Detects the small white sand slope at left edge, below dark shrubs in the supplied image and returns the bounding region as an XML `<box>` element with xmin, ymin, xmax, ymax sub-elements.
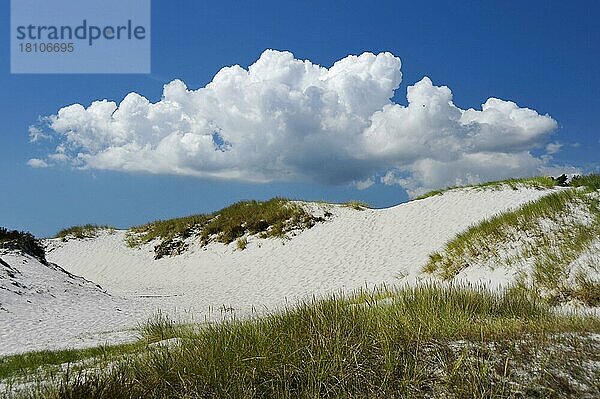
<box><xmin>0</xmin><ymin>252</ymin><xmax>138</xmax><ymax>355</ymax></box>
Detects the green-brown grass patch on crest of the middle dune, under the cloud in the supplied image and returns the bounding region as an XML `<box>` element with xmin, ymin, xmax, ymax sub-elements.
<box><xmin>127</xmin><ymin>198</ymin><xmax>317</xmax><ymax>256</ymax></box>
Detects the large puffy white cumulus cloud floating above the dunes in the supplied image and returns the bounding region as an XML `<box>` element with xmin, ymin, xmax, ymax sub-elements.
<box><xmin>32</xmin><ymin>50</ymin><xmax>557</xmax><ymax>193</ymax></box>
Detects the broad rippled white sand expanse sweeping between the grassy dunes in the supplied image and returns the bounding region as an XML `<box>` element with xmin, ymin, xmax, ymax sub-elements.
<box><xmin>0</xmin><ymin>189</ymin><xmax>548</xmax><ymax>354</ymax></box>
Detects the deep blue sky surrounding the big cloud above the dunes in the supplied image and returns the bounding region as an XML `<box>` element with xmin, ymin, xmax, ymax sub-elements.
<box><xmin>0</xmin><ymin>0</ymin><xmax>600</xmax><ymax>236</ymax></box>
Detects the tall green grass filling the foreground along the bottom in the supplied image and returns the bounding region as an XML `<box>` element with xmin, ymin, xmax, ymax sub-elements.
<box><xmin>4</xmin><ymin>286</ymin><xmax>600</xmax><ymax>398</ymax></box>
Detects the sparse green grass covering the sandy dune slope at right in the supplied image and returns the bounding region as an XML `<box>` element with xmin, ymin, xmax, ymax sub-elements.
<box><xmin>424</xmin><ymin>189</ymin><xmax>600</xmax><ymax>304</ymax></box>
